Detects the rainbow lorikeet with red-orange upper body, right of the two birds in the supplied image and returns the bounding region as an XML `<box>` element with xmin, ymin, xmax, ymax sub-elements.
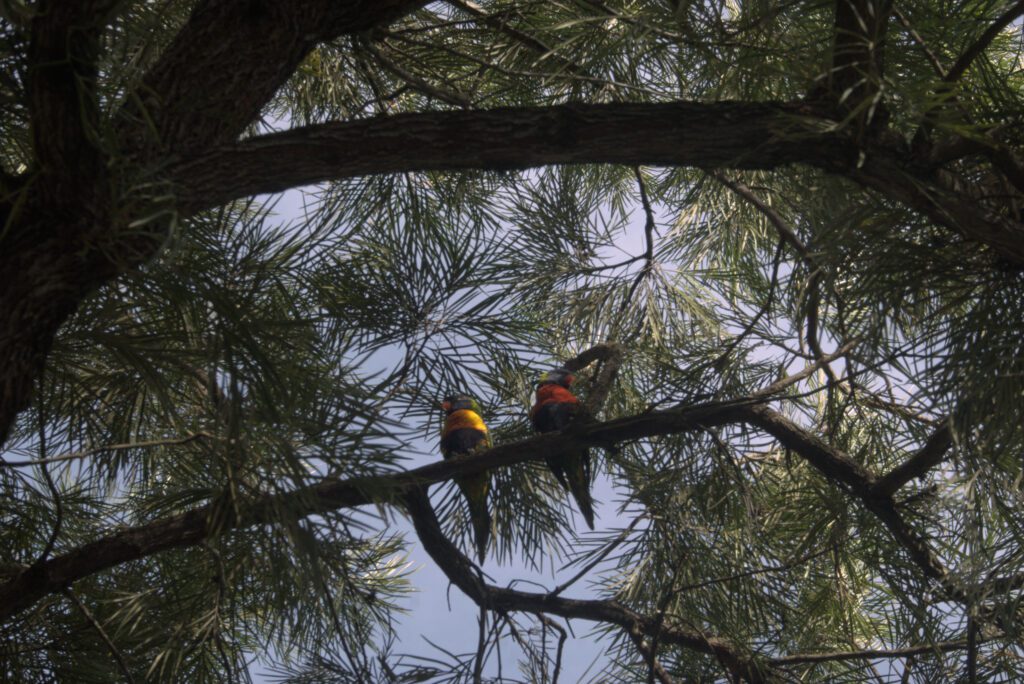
<box><xmin>529</xmin><ymin>369</ymin><xmax>594</xmax><ymax>529</ymax></box>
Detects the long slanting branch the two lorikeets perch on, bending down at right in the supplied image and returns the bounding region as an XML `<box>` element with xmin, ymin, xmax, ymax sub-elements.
<box><xmin>0</xmin><ymin>399</ymin><xmax>965</xmax><ymax>619</ymax></box>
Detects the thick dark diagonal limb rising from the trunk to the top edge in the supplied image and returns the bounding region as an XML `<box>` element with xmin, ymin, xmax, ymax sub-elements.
<box><xmin>125</xmin><ymin>0</ymin><xmax>426</xmax><ymax>158</ymax></box>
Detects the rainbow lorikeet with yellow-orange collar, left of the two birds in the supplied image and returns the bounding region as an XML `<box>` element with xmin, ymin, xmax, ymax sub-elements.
<box><xmin>441</xmin><ymin>394</ymin><xmax>490</xmax><ymax>563</ymax></box>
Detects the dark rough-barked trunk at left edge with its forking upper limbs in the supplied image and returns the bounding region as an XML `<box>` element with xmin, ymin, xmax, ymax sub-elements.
<box><xmin>0</xmin><ymin>0</ymin><xmax>424</xmax><ymax>444</ymax></box>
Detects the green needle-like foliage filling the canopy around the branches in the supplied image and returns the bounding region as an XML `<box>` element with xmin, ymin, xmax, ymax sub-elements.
<box><xmin>0</xmin><ymin>0</ymin><xmax>1024</xmax><ymax>684</ymax></box>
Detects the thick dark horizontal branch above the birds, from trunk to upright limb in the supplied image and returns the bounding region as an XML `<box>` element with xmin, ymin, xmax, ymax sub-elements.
<box><xmin>172</xmin><ymin>101</ymin><xmax>856</xmax><ymax>213</ymax></box>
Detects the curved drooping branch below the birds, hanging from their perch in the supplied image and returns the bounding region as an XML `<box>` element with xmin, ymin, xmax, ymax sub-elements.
<box><xmin>404</xmin><ymin>489</ymin><xmax>771</xmax><ymax>682</ymax></box>
